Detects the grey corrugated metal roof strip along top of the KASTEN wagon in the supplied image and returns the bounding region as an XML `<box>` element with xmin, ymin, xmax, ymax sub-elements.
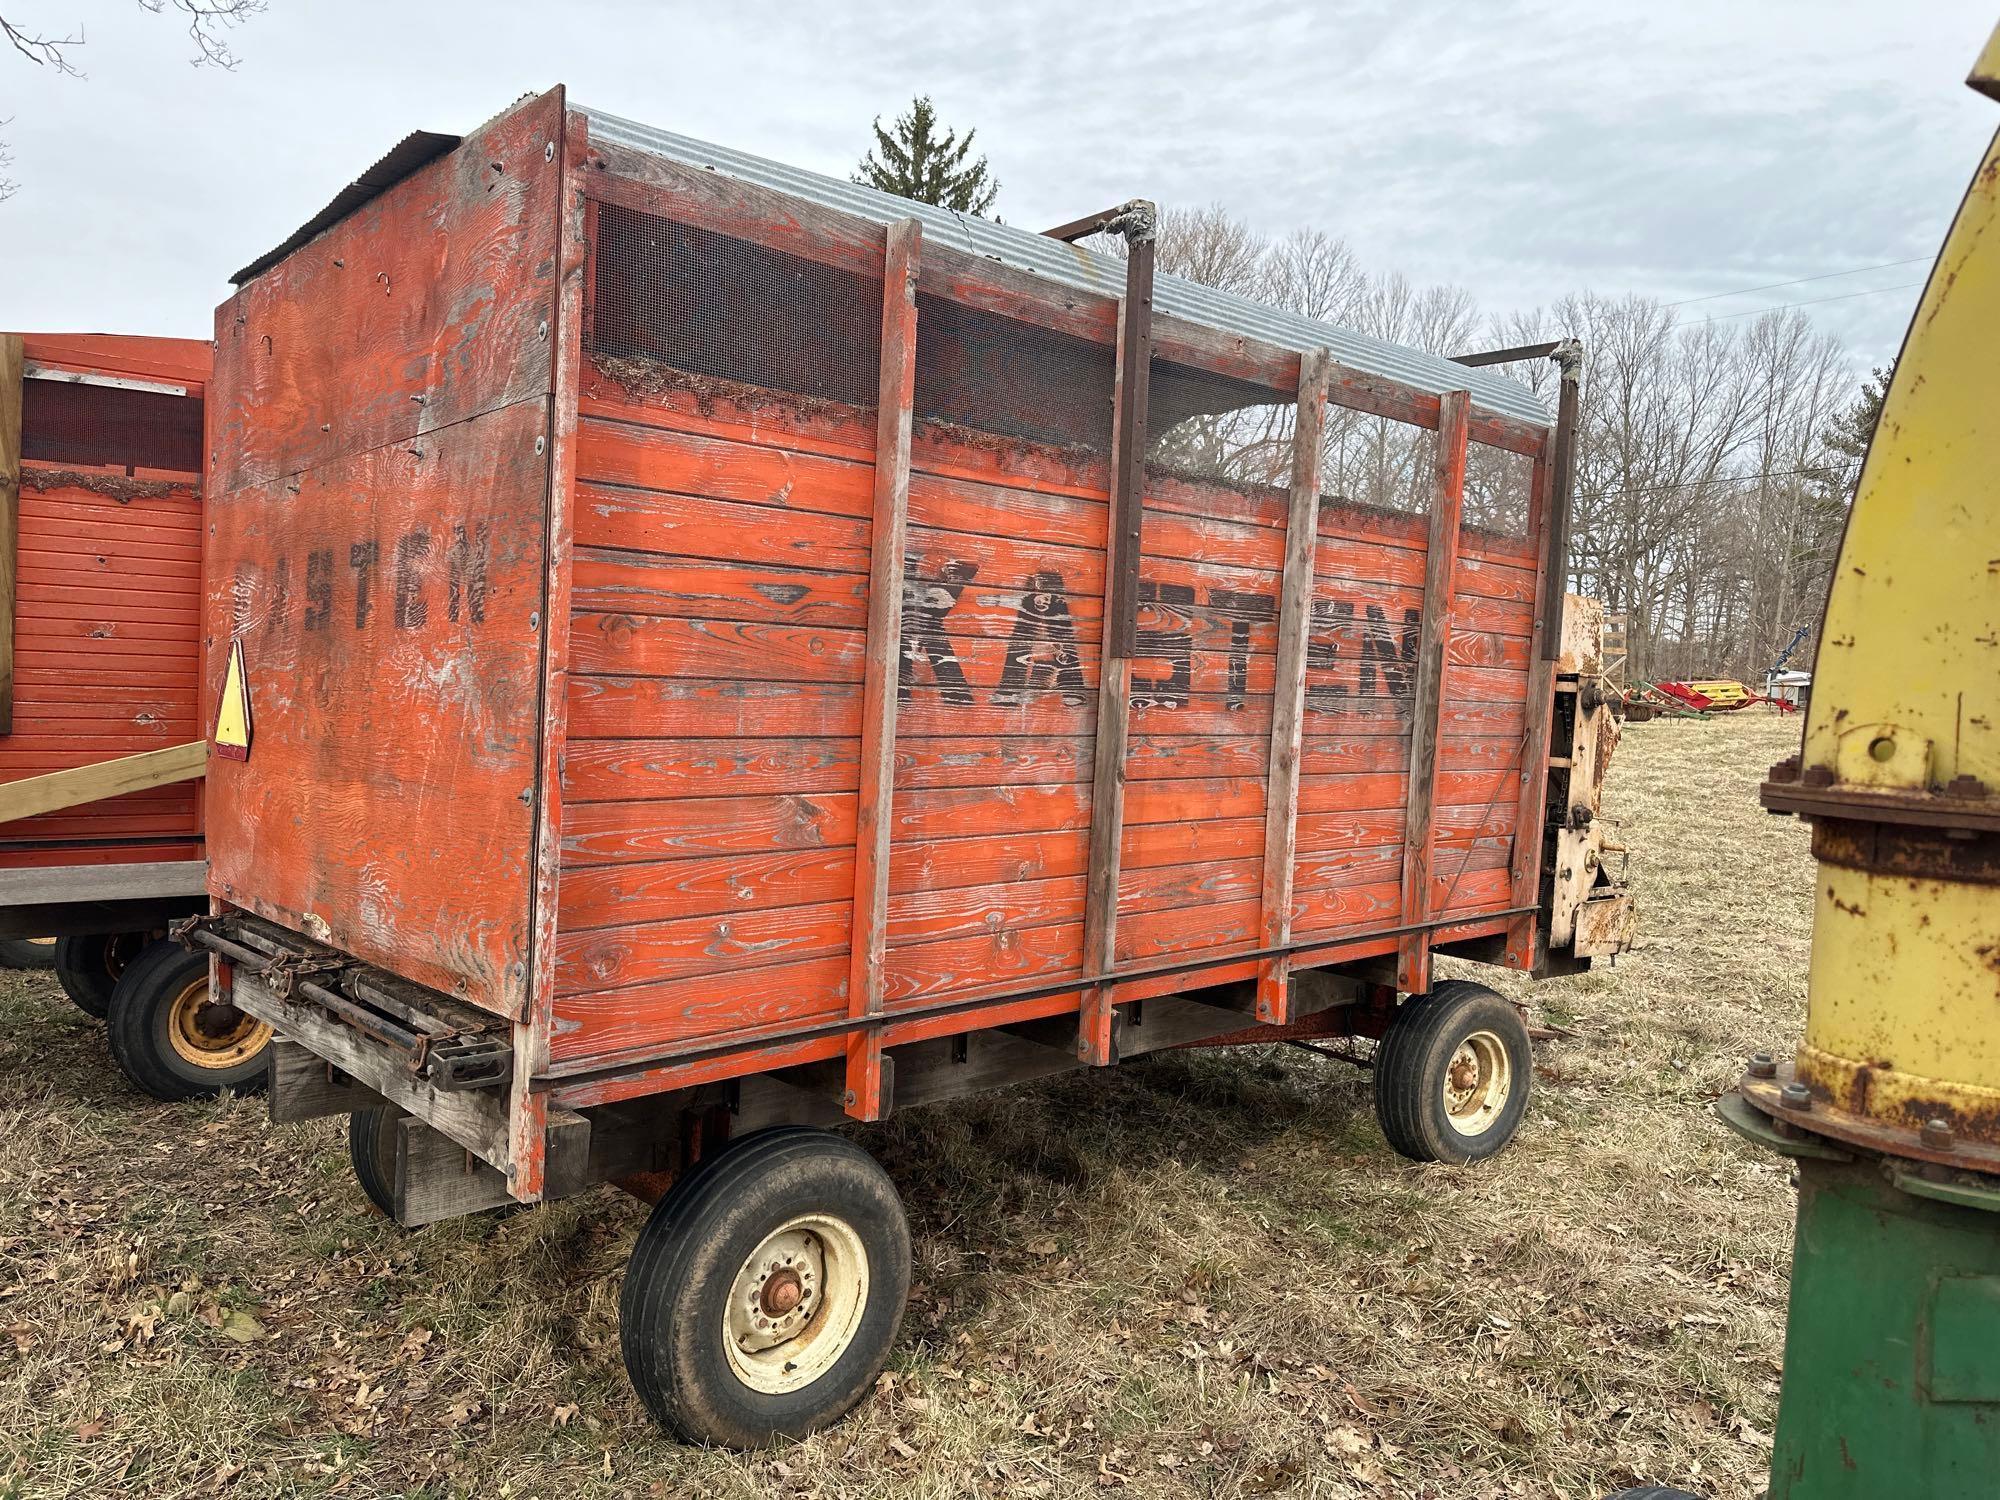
<box><xmin>574</xmin><ymin>104</ymin><xmax>1550</xmax><ymax>426</ymax></box>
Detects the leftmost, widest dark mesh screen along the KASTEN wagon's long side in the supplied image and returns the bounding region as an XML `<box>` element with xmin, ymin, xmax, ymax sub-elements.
<box><xmin>588</xmin><ymin>204</ymin><xmax>882</xmax><ymax>406</ymax></box>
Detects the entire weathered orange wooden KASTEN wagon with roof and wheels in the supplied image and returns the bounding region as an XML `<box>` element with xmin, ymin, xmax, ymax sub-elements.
<box><xmin>184</xmin><ymin>90</ymin><xmax>1628</xmax><ymax>1444</ymax></box>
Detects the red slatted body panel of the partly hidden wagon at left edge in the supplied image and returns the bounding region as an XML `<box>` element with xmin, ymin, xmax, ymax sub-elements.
<box><xmin>0</xmin><ymin>334</ymin><xmax>210</xmax><ymax>868</ymax></box>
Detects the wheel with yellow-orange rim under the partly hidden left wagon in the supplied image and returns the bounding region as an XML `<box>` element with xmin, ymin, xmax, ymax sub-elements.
<box><xmin>108</xmin><ymin>938</ymin><xmax>270</xmax><ymax>1100</ymax></box>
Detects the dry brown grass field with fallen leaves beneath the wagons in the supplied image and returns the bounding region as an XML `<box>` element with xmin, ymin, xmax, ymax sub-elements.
<box><xmin>0</xmin><ymin>710</ymin><xmax>1812</xmax><ymax>1500</ymax></box>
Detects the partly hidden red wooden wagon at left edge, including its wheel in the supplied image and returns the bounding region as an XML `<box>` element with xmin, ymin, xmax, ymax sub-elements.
<box><xmin>0</xmin><ymin>334</ymin><xmax>268</xmax><ymax>1098</ymax></box>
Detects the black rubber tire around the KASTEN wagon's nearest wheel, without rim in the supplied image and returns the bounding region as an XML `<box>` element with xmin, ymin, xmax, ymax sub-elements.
<box><xmin>618</xmin><ymin>1126</ymin><xmax>910</xmax><ymax>1448</ymax></box>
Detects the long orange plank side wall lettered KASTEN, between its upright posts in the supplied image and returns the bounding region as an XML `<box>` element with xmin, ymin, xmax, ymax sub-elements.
<box><xmin>532</xmin><ymin>135</ymin><xmax>1534</xmax><ymax>1078</ymax></box>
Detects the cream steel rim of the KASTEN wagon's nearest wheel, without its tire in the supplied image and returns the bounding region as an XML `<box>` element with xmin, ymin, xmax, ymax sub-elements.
<box><xmin>722</xmin><ymin>1214</ymin><xmax>868</xmax><ymax>1396</ymax></box>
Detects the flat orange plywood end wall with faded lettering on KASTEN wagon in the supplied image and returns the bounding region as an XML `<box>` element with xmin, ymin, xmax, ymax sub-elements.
<box><xmin>206</xmin><ymin>92</ymin><xmax>564</xmax><ymax>1016</ymax></box>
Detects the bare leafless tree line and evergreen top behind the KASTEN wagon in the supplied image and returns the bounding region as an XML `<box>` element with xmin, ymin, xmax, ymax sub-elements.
<box><xmin>856</xmin><ymin>98</ymin><xmax>1886</xmax><ymax>682</ymax></box>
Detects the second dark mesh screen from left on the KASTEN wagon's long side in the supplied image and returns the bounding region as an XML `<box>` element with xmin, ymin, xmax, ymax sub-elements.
<box><xmin>914</xmin><ymin>292</ymin><xmax>1118</xmax><ymax>452</ymax></box>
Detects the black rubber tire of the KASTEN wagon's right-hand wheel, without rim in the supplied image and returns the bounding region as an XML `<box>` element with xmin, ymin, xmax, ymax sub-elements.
<box><xmin>1374</xmin><ymin>980</ymin><xmax>1534</xmax><ymax>1166</ymax></box>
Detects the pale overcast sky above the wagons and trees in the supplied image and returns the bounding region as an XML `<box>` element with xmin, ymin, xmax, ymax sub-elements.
<box><xmin>0</xmin><ymin>0</ymin><xmax>2000</xmax><ymax>376</ymax></box>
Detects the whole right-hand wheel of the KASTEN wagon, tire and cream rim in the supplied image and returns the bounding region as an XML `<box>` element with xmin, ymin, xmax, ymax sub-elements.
<box><xmin>1374</xmin><ymin>980</ymin><xmax>1534</xmax><ymax>1164</ymax></box>
